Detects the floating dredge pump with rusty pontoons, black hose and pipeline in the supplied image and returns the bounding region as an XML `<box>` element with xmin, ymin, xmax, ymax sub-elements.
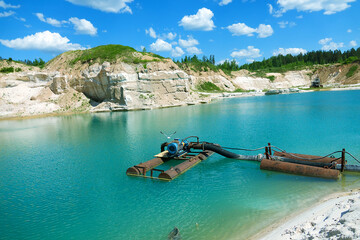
<box><xmin>126</xmin><ymin>136</ymin><xmax>360</xmax><ymax>181</ymax></box>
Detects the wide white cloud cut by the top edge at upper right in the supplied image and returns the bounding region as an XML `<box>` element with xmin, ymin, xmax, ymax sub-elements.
<box><xmin>277</xmin><ymin>0</ymin><xmax>356</xmax><ymax>15</ymax></box>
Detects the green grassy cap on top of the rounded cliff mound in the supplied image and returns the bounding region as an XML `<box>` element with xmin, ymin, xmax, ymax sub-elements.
<box><xmin>70</xmin><ymin>44</ymin><xmax>164</xmax><ymax>64</ymax></box>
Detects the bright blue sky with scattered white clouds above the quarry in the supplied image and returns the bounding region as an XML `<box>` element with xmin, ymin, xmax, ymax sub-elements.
<box><xmin>0</xmin><ymin>0</ymin><xmax>360</xmax><ymax>64</ymax></box>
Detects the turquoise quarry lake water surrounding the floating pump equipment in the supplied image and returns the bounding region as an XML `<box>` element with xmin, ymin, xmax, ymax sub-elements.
<box><xmin>0</xmin><ymin>91</ymin><xmax>360</xmax><ymax>239</ymax></box>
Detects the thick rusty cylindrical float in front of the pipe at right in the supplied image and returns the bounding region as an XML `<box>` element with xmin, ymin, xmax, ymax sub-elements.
<box><xmin>260</xmin><ymin>158</ymin><xmax>340</xmax><ymax>179</ymax></box>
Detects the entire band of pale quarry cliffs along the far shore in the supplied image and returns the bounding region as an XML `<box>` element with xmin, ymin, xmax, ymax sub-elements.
<box><xmin>0</xmin><ymin>52</ymin><xmax>360</xmax><ymax>117</ymax></box>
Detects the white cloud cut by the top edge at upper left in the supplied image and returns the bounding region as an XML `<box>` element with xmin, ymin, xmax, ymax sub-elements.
<box><xmin>67</xmin><ymin>0</ymin><xmax>133</xmax><ymax>13</ymax></box>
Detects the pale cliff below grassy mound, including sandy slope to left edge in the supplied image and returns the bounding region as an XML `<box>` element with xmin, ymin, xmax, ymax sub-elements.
<box><xmin>0</xmin><ymin>56</ymin><xmax>205</xmax><ymax>116</ymax></box>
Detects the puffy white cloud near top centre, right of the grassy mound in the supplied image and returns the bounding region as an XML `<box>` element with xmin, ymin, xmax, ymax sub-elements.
<box><xmin>179</xmin><ymin>8</ymin><xmax>215</xmax><ymax>31</ymax></box>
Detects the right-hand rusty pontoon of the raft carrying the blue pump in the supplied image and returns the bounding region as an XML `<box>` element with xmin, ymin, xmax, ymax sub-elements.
<box><xmin>159</xmin><ymin>151</ymin><xmax>214</xmax><ymax>180</ymax></box>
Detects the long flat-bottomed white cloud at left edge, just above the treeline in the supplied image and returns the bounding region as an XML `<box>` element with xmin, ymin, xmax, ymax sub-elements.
<box><xmin>0</xmin><ymin>31</ymin><xmax>85</xmax><ymax>52</ymax></box>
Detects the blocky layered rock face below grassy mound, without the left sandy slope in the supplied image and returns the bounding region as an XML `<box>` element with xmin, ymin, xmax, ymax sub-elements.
<box><xmin>56</xmin><ymin>60</ymin><xmax>204</xmax><ymax>109</ymax></box>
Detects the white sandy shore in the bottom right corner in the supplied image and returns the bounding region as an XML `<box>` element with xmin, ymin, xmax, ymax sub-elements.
<box><xmin>256</xmin><ymin>189</ymin><xmax>360</xmax><ymax>240</ymax></box>
